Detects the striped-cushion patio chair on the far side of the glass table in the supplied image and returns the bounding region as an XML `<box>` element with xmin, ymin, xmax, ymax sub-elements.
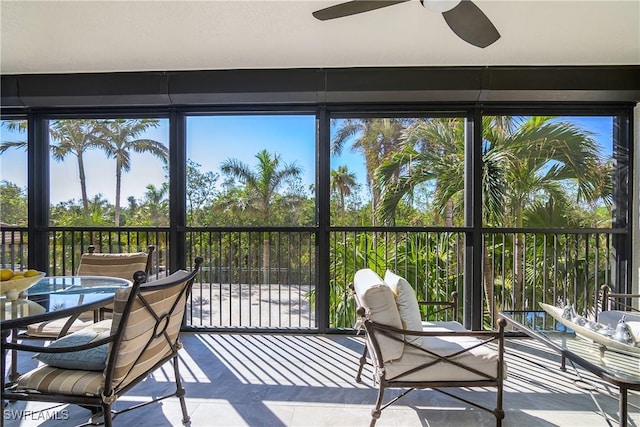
<box><xmin>23</xmin><ymin>245</ymin><xmax>155</xmax><ymax>339</ymax></box>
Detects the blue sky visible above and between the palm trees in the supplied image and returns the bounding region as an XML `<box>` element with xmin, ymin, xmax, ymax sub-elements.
<box><xmin>0</xmin><ymin>115</ymin><xmax>613</xmax><ymax>205</ymax></box>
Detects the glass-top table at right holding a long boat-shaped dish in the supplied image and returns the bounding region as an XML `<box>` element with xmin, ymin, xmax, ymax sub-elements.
<box><xmin>500</xmin><ymin>310</ymin><xmax>640</xmax><ymax>426</ymax></box>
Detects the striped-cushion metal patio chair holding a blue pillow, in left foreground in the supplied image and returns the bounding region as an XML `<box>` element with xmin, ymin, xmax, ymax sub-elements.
<box><xmin>2</xmin><ymin>257</ymin><xmax>202</xmax><ymax>427</ymax></box>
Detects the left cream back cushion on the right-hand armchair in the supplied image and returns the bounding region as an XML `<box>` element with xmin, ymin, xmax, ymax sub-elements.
<box><xmin>353</xmin><ymin>268</ymin><xmax>404</xmax><ymax>362</ymax></box>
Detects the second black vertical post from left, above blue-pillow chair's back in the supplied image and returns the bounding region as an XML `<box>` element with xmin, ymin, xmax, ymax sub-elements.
<box><xmin>167</xmin><ymin>110</ymin><xmax>186</xmax><ymax>271</ymax></box>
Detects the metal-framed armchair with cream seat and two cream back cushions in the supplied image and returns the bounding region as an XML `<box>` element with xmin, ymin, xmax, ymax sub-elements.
<box><xmin>353</xmin><ymin>269</ymin><xmax>506</xmax><ymax>426</ymax></box>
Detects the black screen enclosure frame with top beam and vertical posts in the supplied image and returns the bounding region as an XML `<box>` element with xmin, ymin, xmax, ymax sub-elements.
<box><xmin>1</xmin><ymin>67</ymin><xmax>640</xmax><ymax>333</ymax></box>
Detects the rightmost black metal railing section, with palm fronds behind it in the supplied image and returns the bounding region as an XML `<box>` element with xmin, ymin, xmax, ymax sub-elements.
<box><xmin>484</xmin><ymin>229</ymin><xmax>620</xmax><ymax>313</ymax></box>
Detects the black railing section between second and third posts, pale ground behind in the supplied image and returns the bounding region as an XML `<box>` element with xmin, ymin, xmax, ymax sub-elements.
<box><xmin>187</xmin><ymin>227</ymin><xmax>317</xmax><ymax>329</ymax></box>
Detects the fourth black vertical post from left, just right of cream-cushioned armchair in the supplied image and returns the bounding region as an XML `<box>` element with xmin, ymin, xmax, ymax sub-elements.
<box><xmin>464</xmin><ymin>108</ymin><xmax>483</xmax><ymax>330</ymax></box>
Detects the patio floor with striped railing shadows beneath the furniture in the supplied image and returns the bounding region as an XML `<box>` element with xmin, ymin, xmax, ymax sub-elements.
<box><xmin>4</xmin><ymin>333</ymin><xmax>640</xmax><ymax>427</ymax></box>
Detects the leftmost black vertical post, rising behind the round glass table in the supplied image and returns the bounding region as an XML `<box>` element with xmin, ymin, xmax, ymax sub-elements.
<box><xmin>27</xmin><ymin>113</ymin><xmax>50</xmax><ymax>272</ymax></box>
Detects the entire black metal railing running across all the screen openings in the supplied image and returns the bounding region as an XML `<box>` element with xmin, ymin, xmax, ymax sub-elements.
<box><xmin>0</xmin><ymin>227</ymin><xmax>626</xmax><ymax>330</ymax></box>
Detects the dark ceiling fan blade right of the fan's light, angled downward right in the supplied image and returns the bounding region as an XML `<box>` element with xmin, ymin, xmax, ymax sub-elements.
<box><xmin>442</xmin><ymin>0</ymin><xmax>500</xmax><ymax>48</ymax></box>
